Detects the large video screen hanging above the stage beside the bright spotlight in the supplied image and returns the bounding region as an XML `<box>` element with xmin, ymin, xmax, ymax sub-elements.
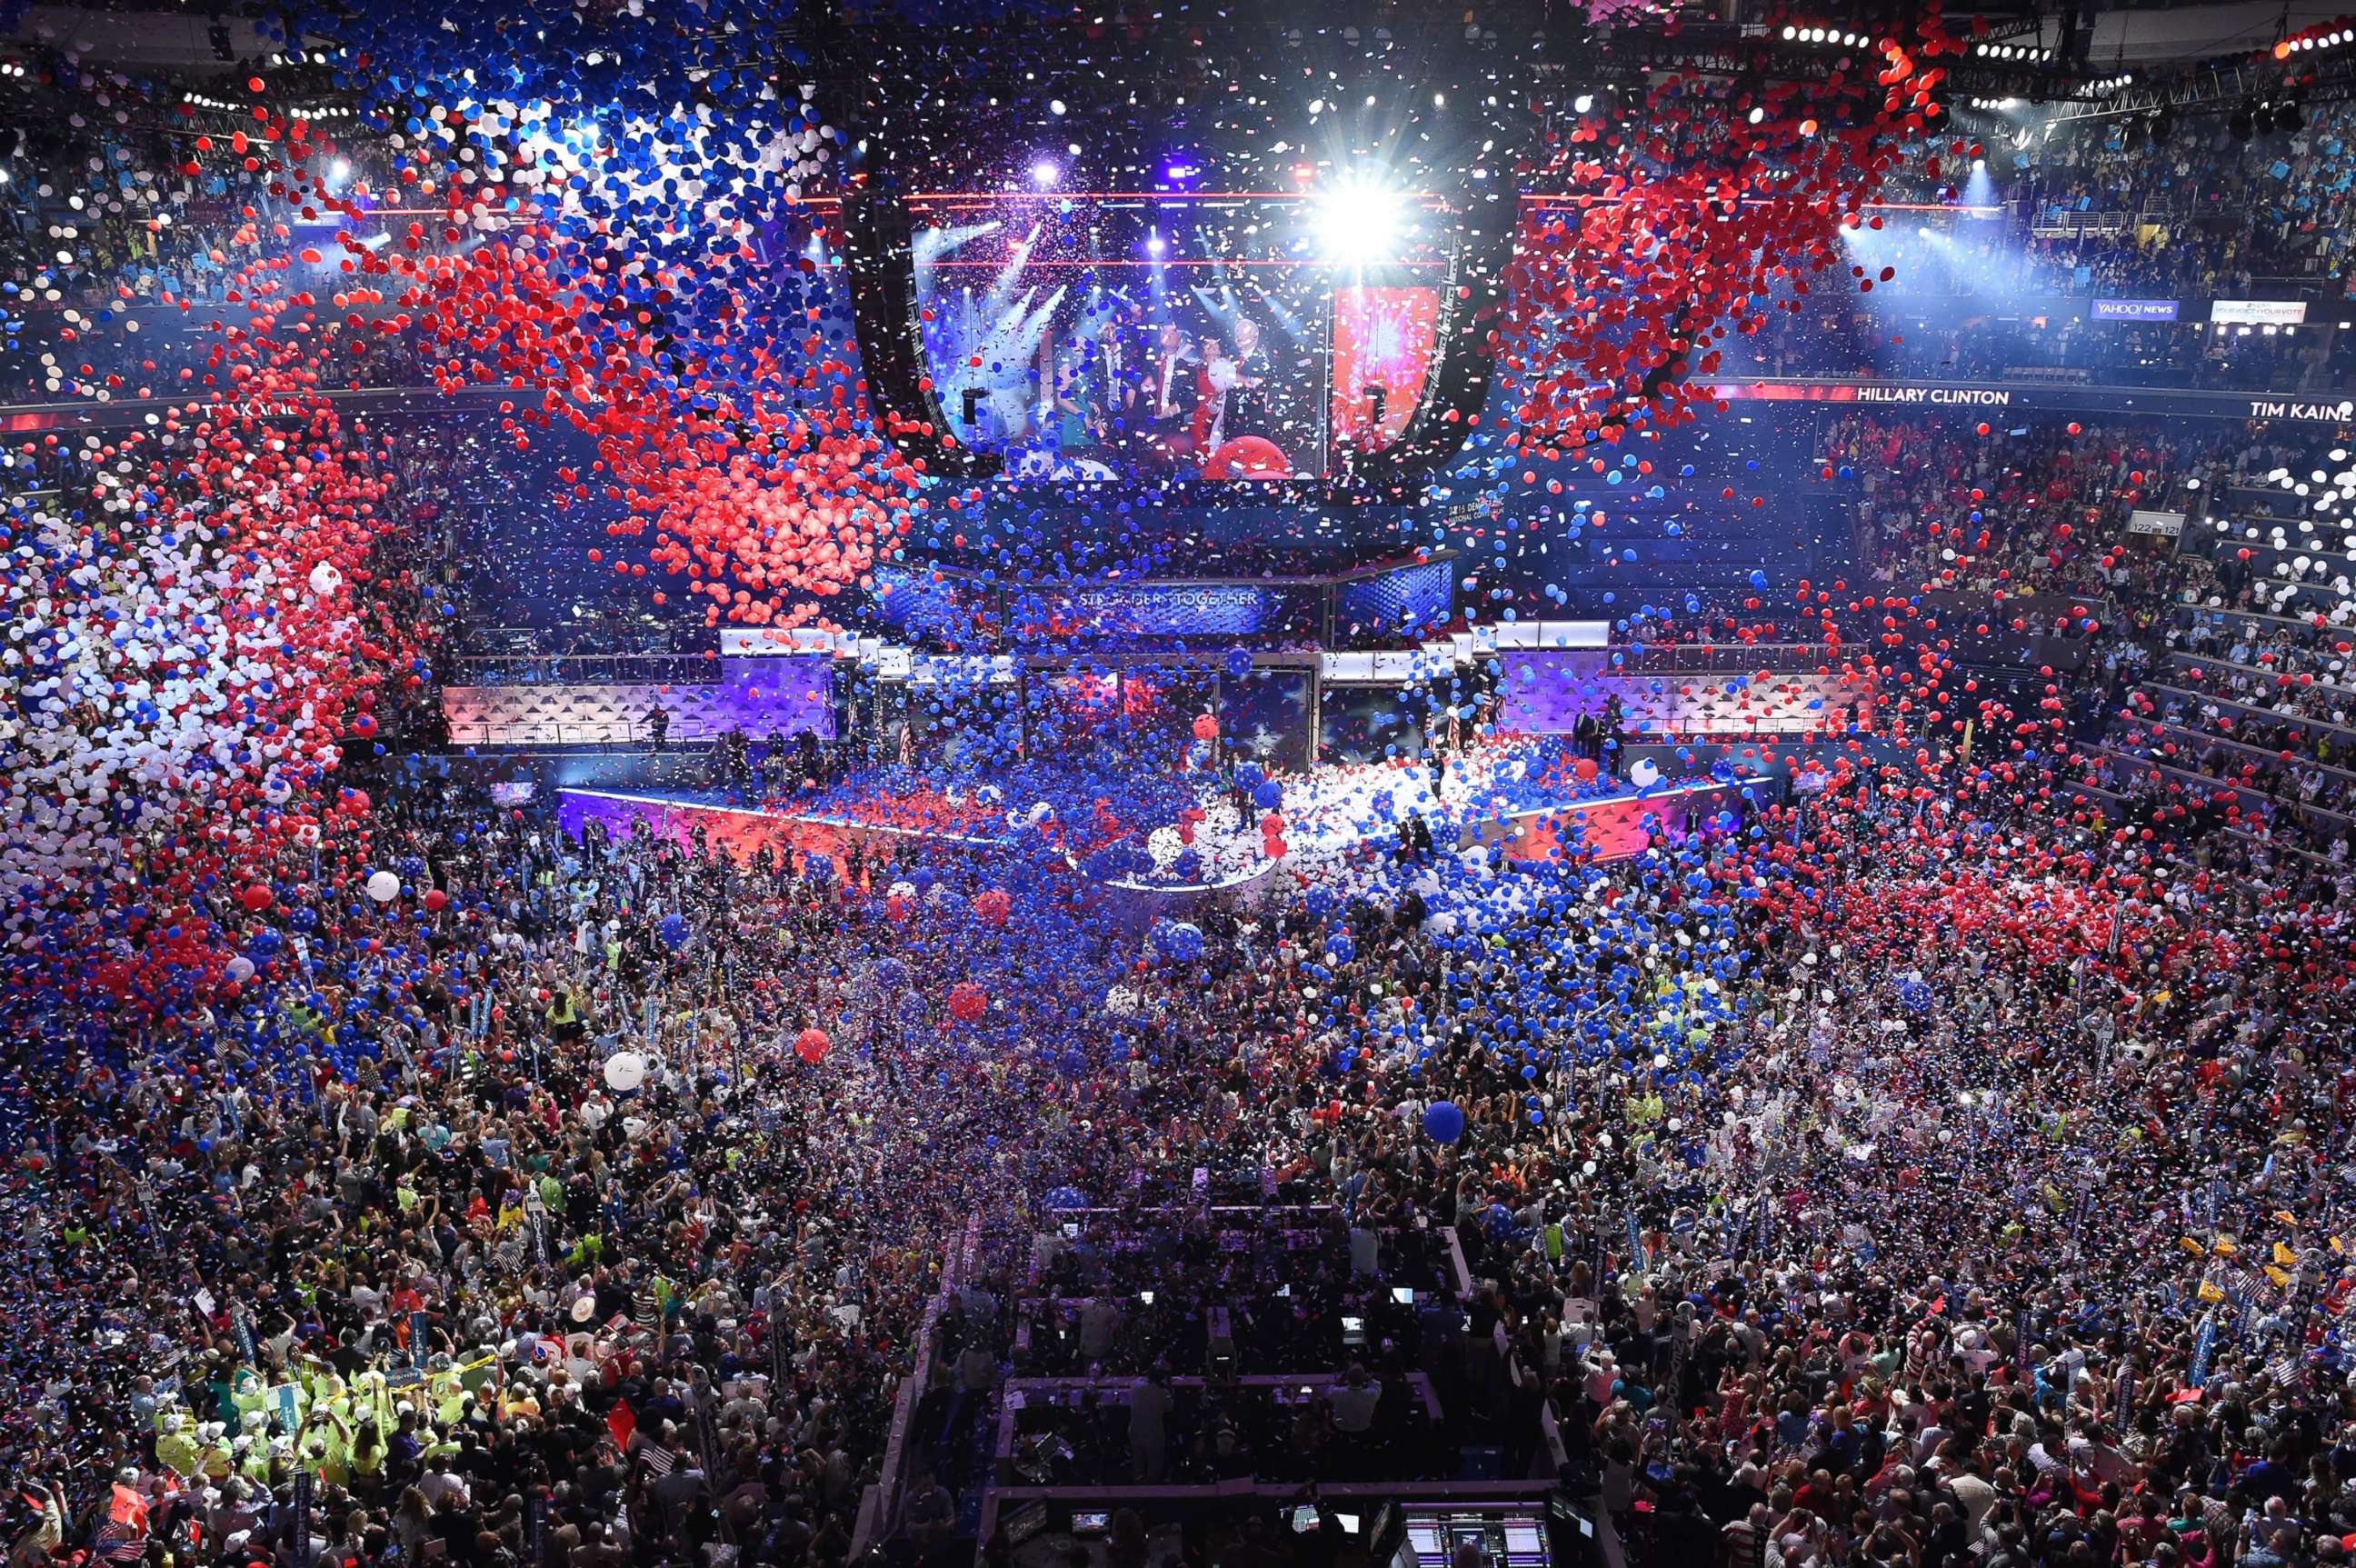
<box><xmin>914</xmin><ymin>195</ymin><xmax>1442</xmax><ymax>483</ymax></box>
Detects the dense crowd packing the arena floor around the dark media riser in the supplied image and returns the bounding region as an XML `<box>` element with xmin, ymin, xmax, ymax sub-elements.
<box><xmin>27</xmin><ymin>683</ymin><xmax>2356</xmax><ymax>1563</ymax></box>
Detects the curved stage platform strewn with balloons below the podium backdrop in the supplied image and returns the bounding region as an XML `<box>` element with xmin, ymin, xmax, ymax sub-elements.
<box><xmin>556</xmin><ymin>749</ymin><xmax>1782</xmax><ymax>902</ymax></box>
